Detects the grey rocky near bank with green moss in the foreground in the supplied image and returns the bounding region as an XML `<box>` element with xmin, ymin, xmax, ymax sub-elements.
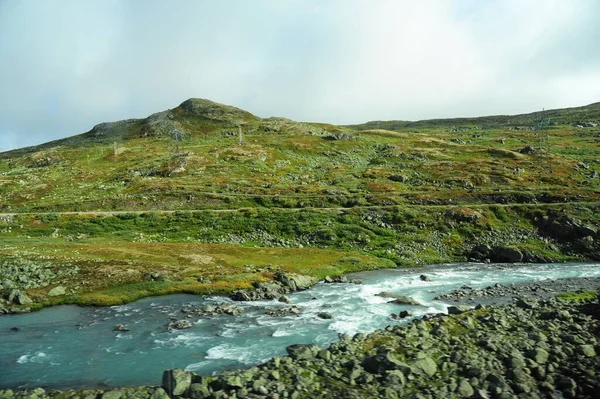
<box><xmin>0</xmin><ymin>279</ymin><xmax>600</xmax><ymax>399</ymax></box>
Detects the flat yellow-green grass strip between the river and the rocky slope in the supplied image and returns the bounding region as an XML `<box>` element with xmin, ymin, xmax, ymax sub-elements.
<box><xmin>0</xmin><ymin>239</ymin><xmax>395</xmax><ymax>307</ymax></box>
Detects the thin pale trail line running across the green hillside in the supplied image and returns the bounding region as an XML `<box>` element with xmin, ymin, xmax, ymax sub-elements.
<box><xmin>0</xmin><ymin>201</ymin><xmax>599</xmax><ymax>218</ymax></box>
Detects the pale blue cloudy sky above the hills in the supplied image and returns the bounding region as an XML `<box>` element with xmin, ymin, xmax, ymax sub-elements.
<box><xmin>0</xmin><ymin>0</ymin><xmax>600</xmax><ymax>151</ymax></box>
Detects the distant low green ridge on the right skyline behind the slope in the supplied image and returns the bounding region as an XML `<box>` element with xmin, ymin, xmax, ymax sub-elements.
<box><xmin>346</xmin><ymin>102</ymin><xmax>600</xmax><ymax>130</ymax></box>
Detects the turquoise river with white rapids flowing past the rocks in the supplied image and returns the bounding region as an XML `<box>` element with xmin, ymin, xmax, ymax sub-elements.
<box><xmin>0</xmin><ymin>263</ymin><xmax>600</xmax><ymax>388</ymax></box>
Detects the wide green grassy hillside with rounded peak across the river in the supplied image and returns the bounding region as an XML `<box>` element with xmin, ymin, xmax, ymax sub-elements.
<box><xmin>0</xmin><ymin>98</ymin><xmax>600</xmax><ymax>310</ymax></box>
